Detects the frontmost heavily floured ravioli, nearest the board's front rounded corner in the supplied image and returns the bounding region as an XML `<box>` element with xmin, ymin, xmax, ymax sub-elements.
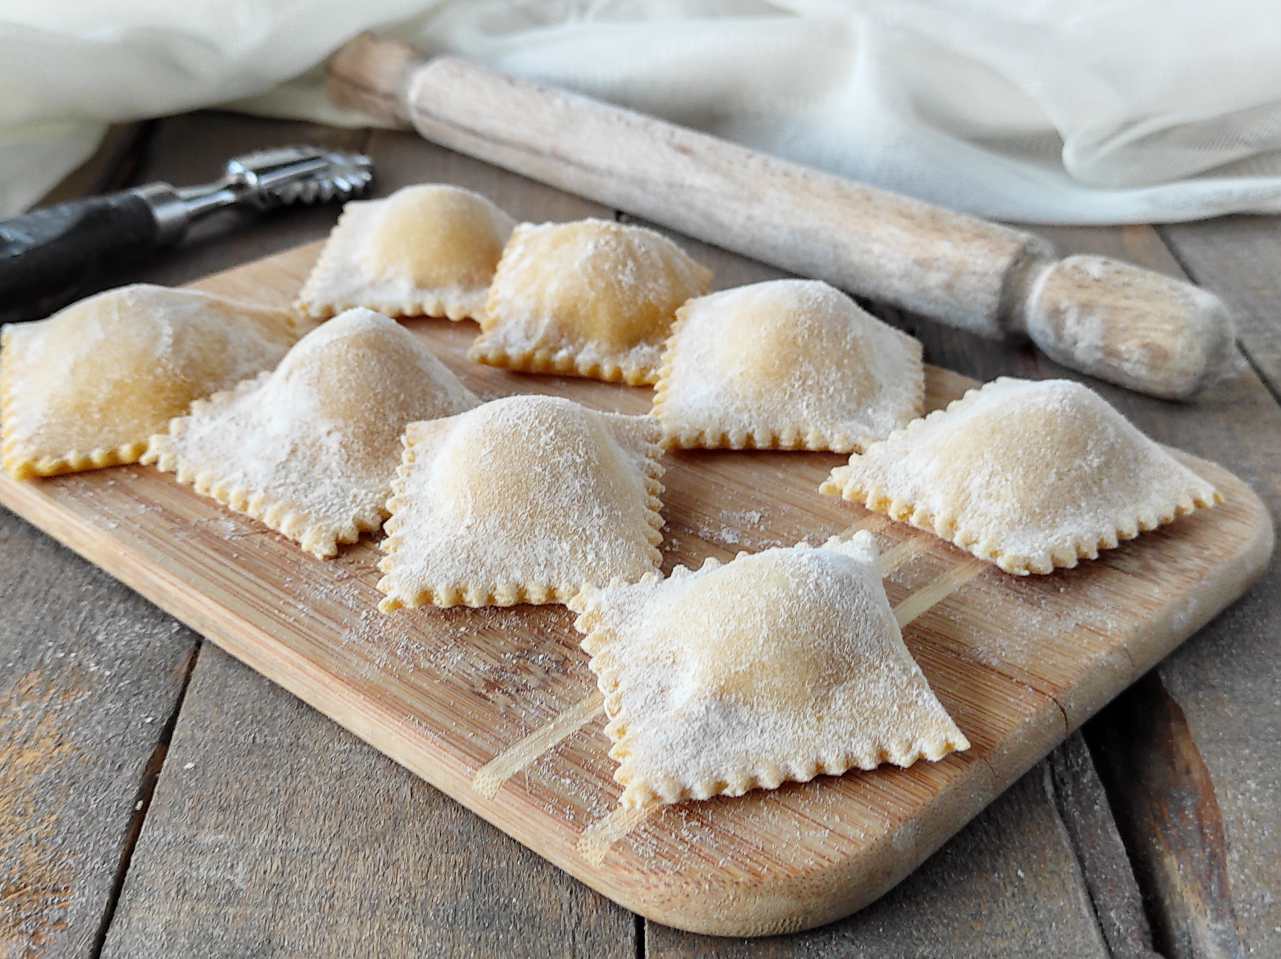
<box><xmin>570</xmin><ymin>531</ymin><xmax>970</xmax><ymax>808</ymax></box>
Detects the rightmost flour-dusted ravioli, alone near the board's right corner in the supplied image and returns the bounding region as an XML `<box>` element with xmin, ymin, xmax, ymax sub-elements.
<box><xmin>821</xmin><ymin>378</ymin><xmax>1220</xmax><ymax>575</ymax></box>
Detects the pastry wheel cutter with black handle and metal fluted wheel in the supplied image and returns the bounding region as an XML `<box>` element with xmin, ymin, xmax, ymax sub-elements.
<box><xmin>0</xmin><ymin>146</ymin><xmax>374</xmax><ymax>323</ymax></box>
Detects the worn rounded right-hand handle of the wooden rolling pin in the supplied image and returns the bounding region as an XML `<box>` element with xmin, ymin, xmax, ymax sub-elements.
<box><xmin>1011</xmin><ymin>256</ymin><xmax>1235</xmax><ymax>399</ymax></box>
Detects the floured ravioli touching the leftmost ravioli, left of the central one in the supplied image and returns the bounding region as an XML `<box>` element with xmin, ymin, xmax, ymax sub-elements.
<box><xmin>143</xmin><ymin>310</ymin><xmax>479</xmax><ymax>558</ymax></box>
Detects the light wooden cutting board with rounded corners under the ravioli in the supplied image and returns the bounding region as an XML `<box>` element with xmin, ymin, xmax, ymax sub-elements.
<box><xmin>0</xmin><ymin>245</ymin><xmax>1273</xmax><ymax>936</ymax></box>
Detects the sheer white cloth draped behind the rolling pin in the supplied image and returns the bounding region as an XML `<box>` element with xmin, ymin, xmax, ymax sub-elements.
<box><xmin>0</xmin><ymin>0</ymin><xmax>1281</xmax><ymax>223</ymax></box>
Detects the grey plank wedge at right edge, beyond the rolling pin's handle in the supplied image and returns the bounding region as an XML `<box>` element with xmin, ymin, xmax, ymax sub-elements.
<box><xmin>1161</xmin><ymin>216</ymin><xmax>1281</xmax><ymax>398</ymax></box>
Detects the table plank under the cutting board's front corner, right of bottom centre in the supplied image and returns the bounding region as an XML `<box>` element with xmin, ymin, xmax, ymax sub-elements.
<box><xmin>646</xmin><ymin>763</ymin><xmax>1108</xmax><ymax>959</ymax></box>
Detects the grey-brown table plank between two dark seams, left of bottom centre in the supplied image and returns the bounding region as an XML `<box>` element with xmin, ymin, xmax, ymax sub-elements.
<box><xmin>104</xmin><ymin>645</ymin><xmax>635</xmax><ymax>959</ymax></box>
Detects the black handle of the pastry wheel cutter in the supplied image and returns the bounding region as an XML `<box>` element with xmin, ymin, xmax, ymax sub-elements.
<box><xmin>0</xmin><ymin>189</ymin><xmax>161</xmax><ymax>323</ymax></box>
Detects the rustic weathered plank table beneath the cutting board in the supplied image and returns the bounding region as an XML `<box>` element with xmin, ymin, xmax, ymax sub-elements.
<box><xmin>0</xmin><ymin>113</ymin><xmax>1281</xmax><ymax>959</ymax></box>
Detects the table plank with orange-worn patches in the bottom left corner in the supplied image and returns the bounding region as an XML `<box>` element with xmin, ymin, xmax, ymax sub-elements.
<box><xmin>0</xmin><ymin>489</ymin><xmax>196</xmax><ymax>956</ymax></box>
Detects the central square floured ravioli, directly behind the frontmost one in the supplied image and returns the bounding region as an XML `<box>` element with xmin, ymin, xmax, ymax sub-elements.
<box><xmin>378</xmin><ymin>396</ymin><xmax>662</xmax><ymax>612</ymax></box>
